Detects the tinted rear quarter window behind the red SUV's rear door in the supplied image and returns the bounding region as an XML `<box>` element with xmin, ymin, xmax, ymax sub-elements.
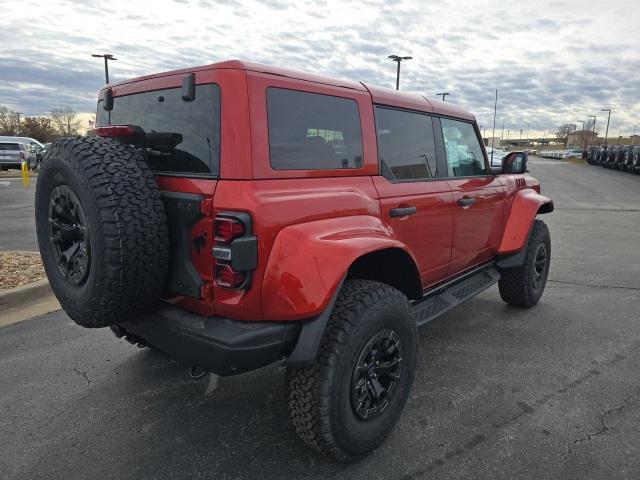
<box><xmin>267</xmin><ymin>87</ymin><xmax>362</xmax><ymax>170</ymax></box>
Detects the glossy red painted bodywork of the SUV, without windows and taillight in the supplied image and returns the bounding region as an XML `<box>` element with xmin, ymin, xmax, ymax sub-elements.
<box><xmin>100</xmin><ymin>60</ymin><xmax>550</xmax><ymax>321</ymax></box>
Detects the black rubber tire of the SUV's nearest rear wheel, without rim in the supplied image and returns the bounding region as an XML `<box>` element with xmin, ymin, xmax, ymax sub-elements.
<box><xmin>286</xmin><ymin>280</ymin><xmax>417</xmax><ymax>460</ymax></box>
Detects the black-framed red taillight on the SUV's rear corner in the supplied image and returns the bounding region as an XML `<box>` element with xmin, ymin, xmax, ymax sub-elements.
<box><xmin>213</xmin><ymin>212</ymin><xmax>258</xmax><ymax>290</ymax></box>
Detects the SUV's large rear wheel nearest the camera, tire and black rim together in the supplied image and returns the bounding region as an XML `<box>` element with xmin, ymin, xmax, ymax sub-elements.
<box><xmin>286</xmin><ymin>280</ymin><xmax>417</xmax><ymax>460</ymax></box>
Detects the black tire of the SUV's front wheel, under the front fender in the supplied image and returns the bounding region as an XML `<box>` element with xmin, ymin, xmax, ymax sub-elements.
<box><xmin>498</xmin><ymin>220</ymin><xmax>551</xmax><ymax>308</ymax></box>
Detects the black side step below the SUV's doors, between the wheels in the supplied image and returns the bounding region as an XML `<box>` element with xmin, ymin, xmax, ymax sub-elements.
<box><xmin>413</xmin><ymin>267</ymin><xmax>500</xmax><ymax>327</ymax></box>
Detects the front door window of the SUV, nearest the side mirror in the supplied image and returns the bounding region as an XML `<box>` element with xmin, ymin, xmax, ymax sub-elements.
<box><xmin>440</xmin><ymin>118</ymin><xmax>486</xmax><ymax>177</ymax></box>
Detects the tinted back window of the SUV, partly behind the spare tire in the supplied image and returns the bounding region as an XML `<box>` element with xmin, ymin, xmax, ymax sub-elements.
<box><xmin>96</xmin><ymin>84</ymin><xmax>220</xmax><ymax>176</ymax></box>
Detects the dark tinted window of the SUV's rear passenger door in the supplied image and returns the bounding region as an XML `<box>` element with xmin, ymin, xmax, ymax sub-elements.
<box><xmin>376</xmin><ymin>107</ymin><xmax>436</xmax><ymax>180</ymax></box>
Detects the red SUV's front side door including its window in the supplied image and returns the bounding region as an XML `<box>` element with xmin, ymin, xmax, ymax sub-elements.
<box><xmin>436</xmin><ymin>118</ymin><xmax>505</xmax><ymax>276</ymax></box>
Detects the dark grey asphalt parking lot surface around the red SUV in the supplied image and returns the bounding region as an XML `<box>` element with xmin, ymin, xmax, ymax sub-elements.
<box><xmin>0</xmin><ymin>158</ymin><xmax>640</xmax><ymax>480</ymax></box>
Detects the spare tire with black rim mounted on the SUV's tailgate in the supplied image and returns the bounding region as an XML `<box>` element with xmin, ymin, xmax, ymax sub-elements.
<box><xmin>35</xmin><ymin>137</ymin><xmax>169</xmax><ymax>328</ymax></box>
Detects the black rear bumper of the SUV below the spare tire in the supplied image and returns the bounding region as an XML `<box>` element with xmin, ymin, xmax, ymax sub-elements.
<box><xmin>114</xmin><ymin>306</ymin><xmax>301</xmax><ymax>376</ymax></box>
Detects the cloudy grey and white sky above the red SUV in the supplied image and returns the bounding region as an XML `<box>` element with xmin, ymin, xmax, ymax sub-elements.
<box><xmin>0</xmin><ymin>0</ymin><xmax>640</xmax><ymax>138</ymax></box>
